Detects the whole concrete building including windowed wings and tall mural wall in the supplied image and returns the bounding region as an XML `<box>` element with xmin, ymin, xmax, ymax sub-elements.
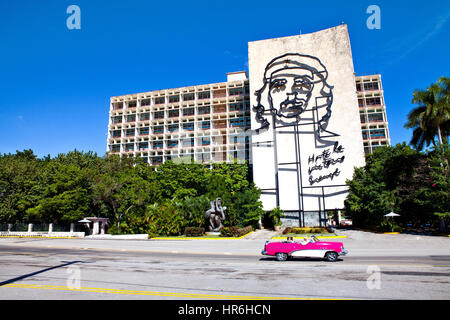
<box><xmin>107</xmin><ymin>25</ymin><xmax>390</xmax><ymax>226</ymax></box>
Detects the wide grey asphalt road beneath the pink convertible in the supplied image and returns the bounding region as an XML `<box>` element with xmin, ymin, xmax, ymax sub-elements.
<box><xmin>0</xmin><ymin>232</ymin><xmax>450</xmax><ymax>300</ymax></box>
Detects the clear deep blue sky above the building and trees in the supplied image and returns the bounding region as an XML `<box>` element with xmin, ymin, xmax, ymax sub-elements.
<box><xmin>0</xmin><ymin>0</ymin><xmax>450</xmax><ymax>157</ymax></box>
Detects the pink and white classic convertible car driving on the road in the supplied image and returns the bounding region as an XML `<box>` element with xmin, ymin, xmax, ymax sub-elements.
<box><xmin>261</xmin><ymin>236</ymin><xmax>348</xmax><ymax>261</ymax></box>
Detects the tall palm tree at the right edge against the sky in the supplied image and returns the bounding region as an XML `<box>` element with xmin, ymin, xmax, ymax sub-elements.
<box><xmin>404</xmin><ymin>77</ymin><xmax>450</xmax><ymax>151</ymax></box>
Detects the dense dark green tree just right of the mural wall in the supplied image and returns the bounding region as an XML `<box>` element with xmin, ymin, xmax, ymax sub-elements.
<box><xmin>345</xmin><ymin>143</ymin><xmax>432</xmax><ymax>229</ymax></box>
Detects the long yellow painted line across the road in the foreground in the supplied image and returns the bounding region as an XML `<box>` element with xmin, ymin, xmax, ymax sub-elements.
<box><xmin>2</xmin><ymin>283</ymin><xmax>349</xmax><ymax>300</ymax></box>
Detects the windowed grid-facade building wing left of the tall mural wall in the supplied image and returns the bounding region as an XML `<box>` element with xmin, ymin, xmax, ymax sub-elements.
<box><xmin>108</xmin><ymin>71</ymin><xmax>250</xmax><ymax>165</ymax></box>
